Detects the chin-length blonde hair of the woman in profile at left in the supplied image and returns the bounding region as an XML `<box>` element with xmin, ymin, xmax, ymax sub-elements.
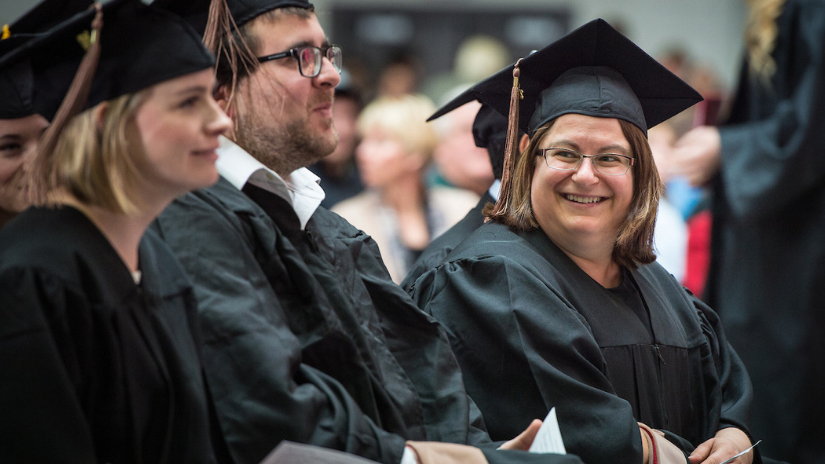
<box><xmin>39</xmin><ymin>89</ymin><xmax>151</xmax><ymax>214</ymax></box>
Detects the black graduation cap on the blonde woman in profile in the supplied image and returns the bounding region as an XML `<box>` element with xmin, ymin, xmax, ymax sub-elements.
<box><xmin>0</xmin><ymin>0</ymin><xmax>214</xmax><ymax>120</ymax></box>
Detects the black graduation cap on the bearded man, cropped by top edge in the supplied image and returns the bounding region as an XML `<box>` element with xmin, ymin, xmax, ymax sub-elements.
<box><xmin>155</xmin><ymin>0</ymin><xmax>314</xmax><ymax>35</ymax></box>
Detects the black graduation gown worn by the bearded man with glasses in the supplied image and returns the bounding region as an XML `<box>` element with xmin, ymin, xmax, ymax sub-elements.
<box><xmin>154</xmin><ymin>178</ymin><xmax>580</xmax><ymax>464</ymax></box>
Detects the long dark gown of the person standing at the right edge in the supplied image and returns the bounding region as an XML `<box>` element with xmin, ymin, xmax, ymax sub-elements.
<box><xmin>704</xmin><ymin>0</ymin><xmax>825</xmax><ymax>463</ymax></box>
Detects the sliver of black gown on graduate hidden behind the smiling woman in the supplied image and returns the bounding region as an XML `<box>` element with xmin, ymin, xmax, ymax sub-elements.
<box><xmin>401</xmin><ymin>192</ymin><xmax>496</xmax><ymax>291</ymax></box>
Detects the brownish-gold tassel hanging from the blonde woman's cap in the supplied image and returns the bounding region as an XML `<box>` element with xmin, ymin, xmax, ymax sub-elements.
<box><xmin>26</xmin><ymin>2</ymin><xmax>103</xmax><ymax>205</ymax></box>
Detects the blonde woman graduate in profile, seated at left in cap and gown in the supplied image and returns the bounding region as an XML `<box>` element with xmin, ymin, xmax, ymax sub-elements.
<box><xmin>0</xmin><ymin>0</ymin><xmax>230</xmax><ymax>458</ymax></box>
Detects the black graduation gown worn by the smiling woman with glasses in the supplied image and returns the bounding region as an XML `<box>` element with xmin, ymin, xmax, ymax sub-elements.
<box><xmin>413</xmin><ymin>224</ymin><xmax>751</xmax><ymax>464</ymax></box>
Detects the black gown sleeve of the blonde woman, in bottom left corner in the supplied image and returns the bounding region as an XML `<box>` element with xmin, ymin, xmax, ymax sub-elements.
<box><xmin>0</xmin><ymin>268</ymin><xmax>96</xmax><ymax>463</ymax></box>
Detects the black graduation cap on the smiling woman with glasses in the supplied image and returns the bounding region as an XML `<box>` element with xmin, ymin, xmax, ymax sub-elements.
<box><xmin>424</xmin><ymin>19</ymin><xmax>702</xmax><ymax>135</ymax></box>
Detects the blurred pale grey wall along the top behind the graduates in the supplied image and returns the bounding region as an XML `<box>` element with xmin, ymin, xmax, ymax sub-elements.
<box><xmin>0</xmin><ymin>0</ymin><xmax>744</xmax><ymax>89</ymax></box>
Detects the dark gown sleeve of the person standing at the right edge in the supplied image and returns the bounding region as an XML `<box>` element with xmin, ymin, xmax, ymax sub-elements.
<box><xmin>720</xmin><ymin>2</ymin><xmax>825</xmax><ymax>219</ymax></box>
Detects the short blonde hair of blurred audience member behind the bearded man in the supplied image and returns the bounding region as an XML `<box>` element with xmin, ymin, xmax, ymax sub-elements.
<box><xmin>357</xmin><ymin>95</ymin><xmax>438</xmax><ymax>161</ymax></box>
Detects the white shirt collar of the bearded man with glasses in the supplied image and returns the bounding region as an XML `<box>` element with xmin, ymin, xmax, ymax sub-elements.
<box><xmin>216</xmin><ymin>136</ymin><xmax>325</xmax><ymax>229</ymax></box>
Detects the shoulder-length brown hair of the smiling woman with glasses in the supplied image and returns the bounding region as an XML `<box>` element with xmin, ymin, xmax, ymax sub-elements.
<box><xmin>485</xmin><ymin>119</ymin><xmax>664</xmax><ymax>269</ymax></box>
